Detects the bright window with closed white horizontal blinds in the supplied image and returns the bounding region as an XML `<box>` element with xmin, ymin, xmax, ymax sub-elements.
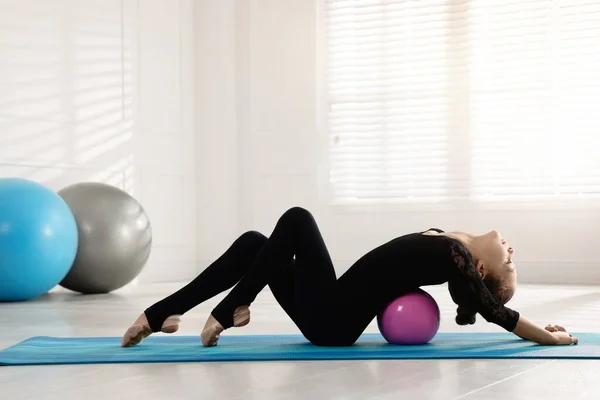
<box><xmin>324</xmin><ymin>0</ymin><xmax>600</xmax><ymax>203</ymax></box>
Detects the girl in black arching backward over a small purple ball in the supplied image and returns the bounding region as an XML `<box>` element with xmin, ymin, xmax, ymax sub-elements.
<box><xmin>121</xmin><ymin>207</ymin><xmax>578</xmax><ymax>347</ymax></box>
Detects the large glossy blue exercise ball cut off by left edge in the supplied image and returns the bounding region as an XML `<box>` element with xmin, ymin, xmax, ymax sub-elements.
<box><xmin>0</xmin><ymin>178</ymin><xmax>78</xmax><ymax>301</ymax></box>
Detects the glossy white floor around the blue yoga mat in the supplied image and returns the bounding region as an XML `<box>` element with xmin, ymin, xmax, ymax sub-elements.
<box><xmin>0</xmin><ymin>285</ymin><xmax>600</xmax><ymax>400</ymax></box>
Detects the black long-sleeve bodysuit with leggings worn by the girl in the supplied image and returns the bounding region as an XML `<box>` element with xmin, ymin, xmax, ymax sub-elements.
<box><xmin>145</xmin><ymin>207</ymin><xmax>519</xmax><ymax>346</ymax></box>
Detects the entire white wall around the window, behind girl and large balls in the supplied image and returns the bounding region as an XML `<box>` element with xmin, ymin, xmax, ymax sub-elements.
<box><xmin>0</xmin><ymin>0</ymin><xmax>600</xmax><ymax>283</ymax></box>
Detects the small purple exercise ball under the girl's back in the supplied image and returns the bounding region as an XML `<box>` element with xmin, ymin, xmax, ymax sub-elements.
<box><xmin>377</xmin><ymin>289</ymin><xmax>440</xmax><ymax>345</ymax></box>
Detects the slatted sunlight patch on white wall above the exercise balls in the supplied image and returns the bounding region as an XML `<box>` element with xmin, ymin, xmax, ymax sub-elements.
<box><xmin>0</xmin><ymin>0</ymin><xmax>135</xmax><ymax>190</ymax></box>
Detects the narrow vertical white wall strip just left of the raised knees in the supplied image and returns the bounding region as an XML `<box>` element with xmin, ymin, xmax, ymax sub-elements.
<box><xmin>190</xmin><ymin>0</ymin><xmax>240</xmax><ymax>270</ymax></box>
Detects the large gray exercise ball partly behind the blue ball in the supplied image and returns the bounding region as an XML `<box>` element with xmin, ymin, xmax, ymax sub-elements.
<box><xmin>58</xmin><ymin>182</ymin><xmax>152</xmax><ymax>294</ymax></box>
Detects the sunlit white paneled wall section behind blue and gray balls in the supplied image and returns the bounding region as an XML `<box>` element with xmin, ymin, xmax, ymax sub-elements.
<box><xmin>0</xmin><ymin>0</ymin><xmax>197</xmax><ymax>281</ymax></box>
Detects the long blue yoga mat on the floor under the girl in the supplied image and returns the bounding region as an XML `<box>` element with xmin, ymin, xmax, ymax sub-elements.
<box><xmin>0</xmin><ymin>333</ymin><xmax>600</xmax><ymax>365</ymax></box>
